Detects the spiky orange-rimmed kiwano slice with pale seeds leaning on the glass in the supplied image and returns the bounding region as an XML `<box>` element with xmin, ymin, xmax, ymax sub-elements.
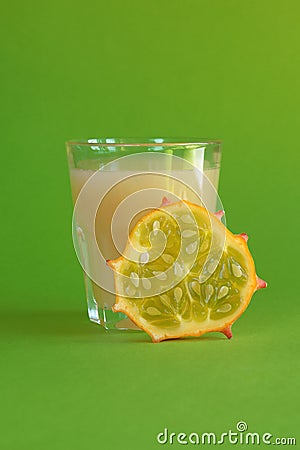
<box><xmin>108</xmin><ymin>201</ymin><xmax>266</xmax><ymax>342</ymax></box>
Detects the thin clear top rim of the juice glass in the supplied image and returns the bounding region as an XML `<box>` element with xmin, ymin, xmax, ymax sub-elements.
<box><xmin>66</xmin><ymin>137</ymin><xmax>222</xmax><ymax>147</ymax></box>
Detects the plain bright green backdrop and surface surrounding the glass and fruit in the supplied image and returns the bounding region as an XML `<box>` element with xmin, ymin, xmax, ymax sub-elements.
<box><xmin>0</xmin><ymin>0</ymin><xmax>300</xmax><ymax>450</ymax></box>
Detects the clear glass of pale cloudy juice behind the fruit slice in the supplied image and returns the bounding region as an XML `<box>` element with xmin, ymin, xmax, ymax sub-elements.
<box><xmin>66</xmin><ymin>138</ymin><xmax>222</xmax><ymax>330</ymax></box>
